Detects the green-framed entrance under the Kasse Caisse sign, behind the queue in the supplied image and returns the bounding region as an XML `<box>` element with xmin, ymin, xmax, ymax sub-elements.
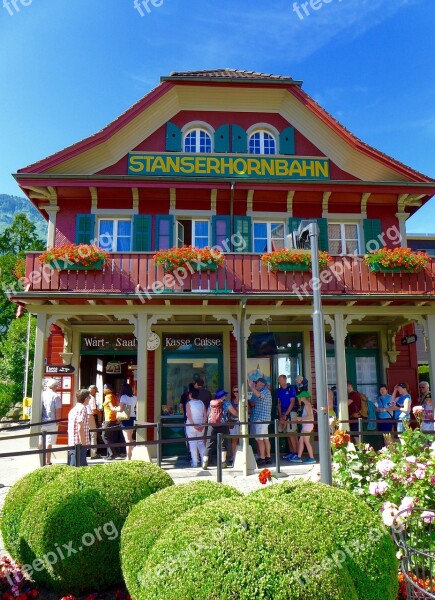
<box><xmin>161</xmin><ymin>353</ymin><xmax>223</xmax><ymax>456</ymax></box>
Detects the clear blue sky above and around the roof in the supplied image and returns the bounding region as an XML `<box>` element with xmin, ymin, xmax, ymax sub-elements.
<box><xmin>0</xmin><ymin>0</ymin><xmax>435</xmax><ymax>232</ymax></box>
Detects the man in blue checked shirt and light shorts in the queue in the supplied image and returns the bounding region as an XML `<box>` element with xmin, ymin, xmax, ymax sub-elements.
<box><xmin>248</xmin><ymin>377</ymin><xmax>272</xmax><ymax>467</ymax></box>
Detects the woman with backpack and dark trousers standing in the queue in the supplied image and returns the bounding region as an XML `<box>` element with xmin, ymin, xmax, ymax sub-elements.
<box><xmin>202</xmin><ymin>389</ymin><xmax>238</xmax><ymax>471</ymax></box>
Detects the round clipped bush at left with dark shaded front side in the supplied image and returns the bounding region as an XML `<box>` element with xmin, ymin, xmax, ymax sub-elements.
<box><xmin>20</xmin><ymin>461</ymin><xmax>173</xmax><ymax>593</ymax></box>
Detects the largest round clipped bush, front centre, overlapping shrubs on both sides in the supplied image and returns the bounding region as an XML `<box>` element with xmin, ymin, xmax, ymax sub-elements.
<box><xmin>141</xmin><ymin>496</ymin><xmax>362</xmax><ymax>600</ymax></box>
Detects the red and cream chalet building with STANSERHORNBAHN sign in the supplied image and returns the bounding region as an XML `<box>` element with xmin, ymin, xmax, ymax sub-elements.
<box><xmin>13</xmin><ymin>69</ymin><xmax>435</xmax><ymax>452</ymax></box>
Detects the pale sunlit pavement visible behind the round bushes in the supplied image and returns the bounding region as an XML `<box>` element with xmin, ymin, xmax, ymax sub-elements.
<box><xmin>0</xmin><ymin>431</ymin><xmax>318</xmax><ymax>554</ymax></box>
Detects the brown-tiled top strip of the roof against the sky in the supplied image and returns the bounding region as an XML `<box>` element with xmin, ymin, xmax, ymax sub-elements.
<box><xmin>160</xmin><ymin>69</ymin><xmax>302</xmax><ymax>86</ymax></box>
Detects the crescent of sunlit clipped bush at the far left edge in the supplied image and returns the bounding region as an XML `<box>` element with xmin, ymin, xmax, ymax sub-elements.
<box><xmin>1</xmin><ymin>465</ymin><xmax>72</xmax><ymax>562</ymax></box>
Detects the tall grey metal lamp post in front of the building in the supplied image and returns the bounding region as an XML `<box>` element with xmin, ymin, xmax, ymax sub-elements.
<box><xmin>300</xmin><ymin>222</ymin><xmax>332</xmax><ymax>485</ymax></box>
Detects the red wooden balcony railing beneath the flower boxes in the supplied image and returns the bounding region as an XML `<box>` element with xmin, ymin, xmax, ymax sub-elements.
<box><xmin>24</xmin><ymin>253</ymin><xmax>435</xmax><ymax>296</ymax></box>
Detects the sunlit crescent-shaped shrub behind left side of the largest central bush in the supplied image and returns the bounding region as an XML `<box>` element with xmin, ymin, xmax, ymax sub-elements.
<box><xmin>121</xmin><ymin>481</ymin><xmax>242</xmax><ymax>600</ymax></box>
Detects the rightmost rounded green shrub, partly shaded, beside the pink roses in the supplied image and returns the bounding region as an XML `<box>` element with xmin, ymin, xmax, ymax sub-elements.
<box><xmin>250</xmin><ymin>481</ymin><xmax>398</xmax><ymax>600</ymax></box>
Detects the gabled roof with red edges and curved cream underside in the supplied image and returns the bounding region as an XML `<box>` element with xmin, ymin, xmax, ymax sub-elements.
<box><xmin>16</xmin><ymin>69</ymin><xmax>434</xmax><ymax>184</ymax></box>
